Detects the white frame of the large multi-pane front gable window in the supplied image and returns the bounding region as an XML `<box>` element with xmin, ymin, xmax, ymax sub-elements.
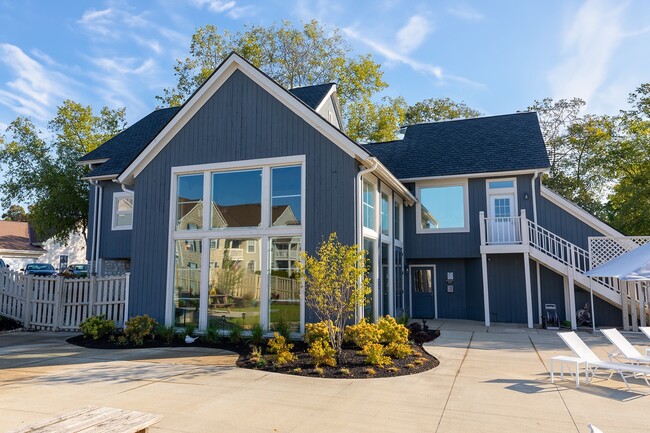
<box><xmin>165</xmin><ymin>155</ymin><xmax>307</xmax><ymax>333</ymax></box>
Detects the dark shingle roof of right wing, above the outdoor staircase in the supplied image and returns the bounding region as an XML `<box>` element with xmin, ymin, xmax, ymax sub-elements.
<box><xmin>364</xmin><ymin>112</ymin><xmax>550</xmax><ymax>179</ymax></box>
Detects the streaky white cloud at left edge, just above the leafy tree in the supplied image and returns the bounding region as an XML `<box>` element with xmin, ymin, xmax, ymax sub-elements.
<box><xmin>0</xmin><ymin>44</ymin><xmax>72</xmax><ymax>121</ymax></box>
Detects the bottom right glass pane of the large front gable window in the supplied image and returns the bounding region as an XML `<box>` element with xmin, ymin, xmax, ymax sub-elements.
<box><xmin>269</xmin><ymin>237</ymin><xmax>301</xmax><ymax>332</ymax></box>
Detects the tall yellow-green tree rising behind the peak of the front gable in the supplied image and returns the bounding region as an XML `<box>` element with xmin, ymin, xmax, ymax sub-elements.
<box><xmin>157</xmin><ymin>20</ymin><xmax>388</xmax><ymax>138</ymax></box>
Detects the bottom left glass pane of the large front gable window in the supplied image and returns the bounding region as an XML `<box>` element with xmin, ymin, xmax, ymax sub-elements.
<box><xmin>174</xmin><ymin>239</ymin><xmax>201</xmax><ymax>326</ymax></box>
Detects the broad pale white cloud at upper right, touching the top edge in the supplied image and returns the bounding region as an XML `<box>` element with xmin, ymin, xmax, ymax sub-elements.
<box><xmin>549</xmin><ymin>0</ymin><xmax>625</xmax><ymax>112</ymax></box>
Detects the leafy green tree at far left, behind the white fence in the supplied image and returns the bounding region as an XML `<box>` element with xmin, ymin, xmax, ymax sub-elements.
<box><xmin>0</xmin><ymin>100</ymin><xmax>126</xmax><ymax>242</ymax></box>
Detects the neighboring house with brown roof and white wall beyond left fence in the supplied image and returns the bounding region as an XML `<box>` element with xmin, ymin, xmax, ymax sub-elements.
<box><xmin>0</xmin><ymin>221</ymin><xmax>86</xmax><ymax>270</ymax></box>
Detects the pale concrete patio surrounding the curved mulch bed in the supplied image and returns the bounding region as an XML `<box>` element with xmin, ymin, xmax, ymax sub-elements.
<box><xmin>0</xmin><ymin>321</ymin><xmax>650</xmax><ymax>433</ymax></box>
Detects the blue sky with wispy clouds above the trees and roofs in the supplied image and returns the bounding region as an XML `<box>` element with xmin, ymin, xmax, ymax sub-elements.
<box><xmin>0</xmin><ymin>0</ymin><xmax>650</xmax><ymax>129</ymax></box>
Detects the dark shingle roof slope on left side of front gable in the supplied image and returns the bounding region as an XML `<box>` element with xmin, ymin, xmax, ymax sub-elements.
<box><xmin>80</xmin><ymin>107</ymin><xmax>181</xmax><ymax>177</ymax></box>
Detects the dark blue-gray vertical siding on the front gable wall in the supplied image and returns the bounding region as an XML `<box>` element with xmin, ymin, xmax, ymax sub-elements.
<box><xmin>130</xmin><ymin>71</ymin><xmax>358</xmax><ymax>321</ymax></box>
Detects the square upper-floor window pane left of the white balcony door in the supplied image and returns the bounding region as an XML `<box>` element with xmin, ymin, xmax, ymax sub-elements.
<box><xmin>417</xmin><ymin>182</ymin><xmax>469</xmax><ymax>233</ymax></box>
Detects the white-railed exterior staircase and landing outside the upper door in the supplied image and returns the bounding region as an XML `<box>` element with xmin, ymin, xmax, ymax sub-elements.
<box><xmin>480</xmin><ymin>210</ymin><xmax>647</xmax><ymax>329</ymax></box>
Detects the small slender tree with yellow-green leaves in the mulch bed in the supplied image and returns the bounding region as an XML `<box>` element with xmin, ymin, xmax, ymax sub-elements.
<box><xmin>298</xmin><ymin>233</ymin><xmax>371</xmax><ymax>357</ymax></box>
